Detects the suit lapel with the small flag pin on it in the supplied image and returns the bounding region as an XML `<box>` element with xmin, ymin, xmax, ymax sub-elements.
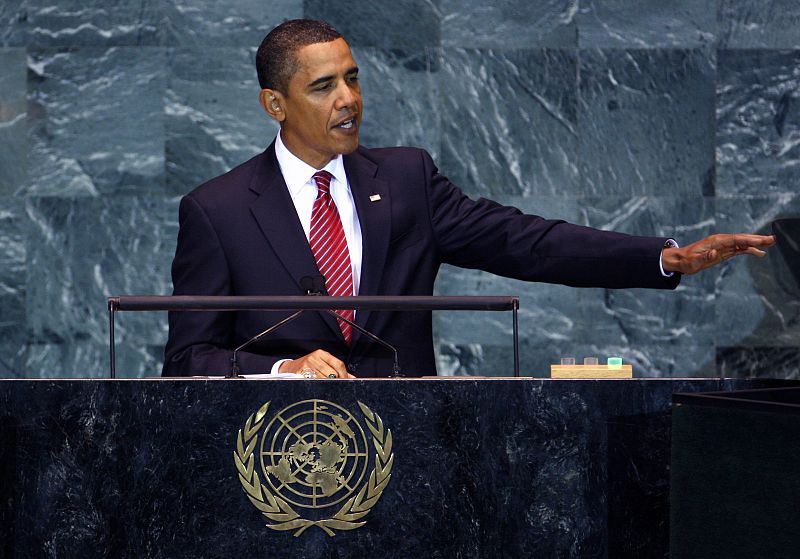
<box><xmin>344</xmin><ymin>151</ymin><xmax>392</xmax><ymax>346</ymax></box>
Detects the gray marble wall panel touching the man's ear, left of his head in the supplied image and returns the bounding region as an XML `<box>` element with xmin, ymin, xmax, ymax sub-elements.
<box><xmin>165</xmin><ymin>47</ymin><xmax>278</xmax><ymax>195</ymax></box>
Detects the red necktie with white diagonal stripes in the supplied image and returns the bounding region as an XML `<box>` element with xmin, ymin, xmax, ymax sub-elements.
<box><xmin>309</xmin><ymin>171</ymin><xmax>355</xmax><ymax>345</ymax></box>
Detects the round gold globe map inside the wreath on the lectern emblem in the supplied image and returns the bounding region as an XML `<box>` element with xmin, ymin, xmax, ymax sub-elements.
<box><xmin>260</xmin><ymin>400</ymin><xmax>369</xmax><ymax>509</ymax></box>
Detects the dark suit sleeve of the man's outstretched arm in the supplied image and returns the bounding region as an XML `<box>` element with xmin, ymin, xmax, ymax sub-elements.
<box><xmin>422</xmin><ymin>152</ymin><xmax>680</xmax><ymax>289</ymax></box>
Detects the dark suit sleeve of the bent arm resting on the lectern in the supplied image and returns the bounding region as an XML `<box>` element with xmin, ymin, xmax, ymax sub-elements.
<box><xmin>162</xmin><ymin>195</ymin><xmax>276</xmax><ymax>376</ymax></box>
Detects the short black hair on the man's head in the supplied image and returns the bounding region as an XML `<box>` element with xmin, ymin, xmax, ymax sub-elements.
<box><xmin>256</xmin><ymin>19</ymin><xmax>342</xmax><ymax>95</ymax></box>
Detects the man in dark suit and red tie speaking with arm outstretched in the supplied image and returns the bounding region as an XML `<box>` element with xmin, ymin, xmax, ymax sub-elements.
<box><xmin>164</xmin><ymin>20</ymin><xmax>774</xmax><ymax>378</ymax></box>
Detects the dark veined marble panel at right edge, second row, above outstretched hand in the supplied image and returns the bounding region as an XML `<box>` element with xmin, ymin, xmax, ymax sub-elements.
<box><xmin>717</xmin><ymin>50</ymin><xmax>800</xmax><ymax>196</ymax></box>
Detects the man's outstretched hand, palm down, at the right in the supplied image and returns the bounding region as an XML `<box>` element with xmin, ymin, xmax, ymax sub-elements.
<box><xmin>661</xmin><ymin>234</ymin><xmax>775</xmax><ymax>274</ymax></box>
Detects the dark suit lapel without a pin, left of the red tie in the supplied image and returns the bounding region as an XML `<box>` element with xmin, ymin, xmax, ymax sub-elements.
<box><xmin>249</xmin><ymin>142</ymin><xmax>344</xmax><ymax>343</ymax></box>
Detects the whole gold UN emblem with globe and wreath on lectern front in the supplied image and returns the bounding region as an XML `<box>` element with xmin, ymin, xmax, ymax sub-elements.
<box><xmin>233</xmin><ymin>400</ymin><xmax>394</xmax><ymax>536</ymax></box>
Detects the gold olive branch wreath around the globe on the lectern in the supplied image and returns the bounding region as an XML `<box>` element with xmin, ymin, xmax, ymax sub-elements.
<box><xmin>233</xmin><ymin>402</ymin><xmax>394</xmax><ymax>537</ymax></box>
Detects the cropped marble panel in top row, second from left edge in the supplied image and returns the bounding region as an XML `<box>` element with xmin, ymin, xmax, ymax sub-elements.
<box><xmin>27</xmin><ymin>0</ymin><xmax>164</xmax><ymax>47</ymax></box>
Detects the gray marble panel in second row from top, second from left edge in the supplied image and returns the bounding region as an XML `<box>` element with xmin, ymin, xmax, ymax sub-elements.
<box><xmin>22</xmin><ymin>47</ymin><xmax>164</xmax><ymax>196</ymax></box>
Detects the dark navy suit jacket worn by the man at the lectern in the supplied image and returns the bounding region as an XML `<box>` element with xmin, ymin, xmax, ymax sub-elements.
<box><xmin>163</xmin><ymin>144</ymin><xmax>679</xmax><ymax>376</ymax></box>
